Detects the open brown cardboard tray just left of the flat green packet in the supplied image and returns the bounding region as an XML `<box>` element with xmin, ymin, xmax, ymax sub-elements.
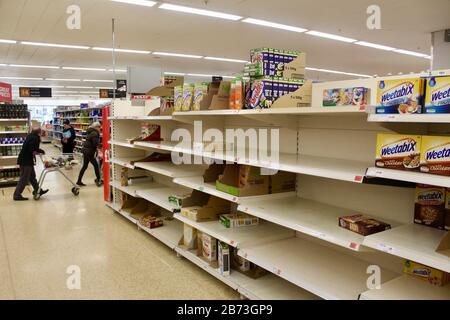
<box><xmin>181</xmin><ymin>190</ymin><xmax>231</xmax><ymax>222</ymax></box>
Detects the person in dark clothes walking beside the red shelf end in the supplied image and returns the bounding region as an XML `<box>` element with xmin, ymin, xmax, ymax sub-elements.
<box><xmin>77</xmin><ymin>122</ymin><xmax>102</xmax><ymax>187</ymax></box>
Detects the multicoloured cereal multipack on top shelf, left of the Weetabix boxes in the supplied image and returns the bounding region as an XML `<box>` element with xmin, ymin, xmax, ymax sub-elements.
<box><xmin>322</xmin><ymin>87</ymin><xmax>369</xmax><ymax>107</ymax></box>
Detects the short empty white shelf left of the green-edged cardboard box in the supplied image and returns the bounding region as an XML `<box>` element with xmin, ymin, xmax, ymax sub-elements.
<box><xmin>134</xmin><ymin>161</ymin><xmax>206</xmax><ymax>178</ymax></box>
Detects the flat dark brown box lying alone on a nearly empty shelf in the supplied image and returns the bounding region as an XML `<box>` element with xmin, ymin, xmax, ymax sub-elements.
<box><xmin>339</xmin><ymin>214</ymin><xmax>391</xmax><ymax>236</ymax></box>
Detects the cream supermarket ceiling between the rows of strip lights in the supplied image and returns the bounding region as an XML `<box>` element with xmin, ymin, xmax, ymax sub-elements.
<box><xmin>0</xmin><ymin>0</ymin><xmax>450</xmax><ymax>90</ymax></box>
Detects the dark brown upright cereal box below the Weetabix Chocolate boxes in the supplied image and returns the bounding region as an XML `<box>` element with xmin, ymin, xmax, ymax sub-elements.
<box><xmin>414</xmin><ymin>185</ymin><xmax>445</xmax><ymax>229</ymax></box>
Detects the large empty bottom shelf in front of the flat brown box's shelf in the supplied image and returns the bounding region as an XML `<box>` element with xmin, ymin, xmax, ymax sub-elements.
<box><xmin>238</xmin><ymin>238</ymin><xmax>396</xmax><ymax>300</ymax></box>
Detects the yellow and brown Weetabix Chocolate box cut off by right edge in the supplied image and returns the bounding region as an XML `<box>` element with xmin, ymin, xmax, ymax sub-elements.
<box><xmin>420</xmin><ymin>136</ymin><xmax>450</xmax><ymax>176</ymax></box>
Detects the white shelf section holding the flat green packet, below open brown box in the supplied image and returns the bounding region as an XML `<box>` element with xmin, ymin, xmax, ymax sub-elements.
<box><xmin>174</xmin><ymin>214</ymin><xmax>295</xmax><ymax>248</ymax></box>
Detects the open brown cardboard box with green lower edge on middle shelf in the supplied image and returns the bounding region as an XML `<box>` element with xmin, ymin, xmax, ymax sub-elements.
<box><xmin>216</xmin><ymin>164</ymin><xmax>269</xmax><ymax>197</ymax></box>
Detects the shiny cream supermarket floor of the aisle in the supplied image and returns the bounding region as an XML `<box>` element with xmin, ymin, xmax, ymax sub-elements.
<box><xmin>0</xmin><ymin>146</ymin><xmax>239</xmax><ymax>299</ymax></box>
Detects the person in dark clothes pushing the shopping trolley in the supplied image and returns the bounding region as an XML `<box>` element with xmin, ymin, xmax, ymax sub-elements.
<box><xmin>14</xmin><ymin>128</ymin><xmax>48</xmax><ymax>201</ymax></box>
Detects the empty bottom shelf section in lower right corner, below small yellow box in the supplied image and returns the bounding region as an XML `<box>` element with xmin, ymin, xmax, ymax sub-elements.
<box><xmin>360</xmin><ymin>275</ymin><xmax>450</xmax><ymax>300</ymax></box>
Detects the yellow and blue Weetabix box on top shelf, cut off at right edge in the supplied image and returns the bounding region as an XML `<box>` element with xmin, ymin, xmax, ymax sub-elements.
<box><xmin>424</xmin><ymin>76</ymin><xmax>450</xmax><ymax>113</ymax></box>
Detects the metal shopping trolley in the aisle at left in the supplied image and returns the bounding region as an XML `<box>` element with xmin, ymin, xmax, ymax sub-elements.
<box><xmin>33</xmin><ymin>153</ymin><xmax>80</xmax><ymax>200</ymax></box>
